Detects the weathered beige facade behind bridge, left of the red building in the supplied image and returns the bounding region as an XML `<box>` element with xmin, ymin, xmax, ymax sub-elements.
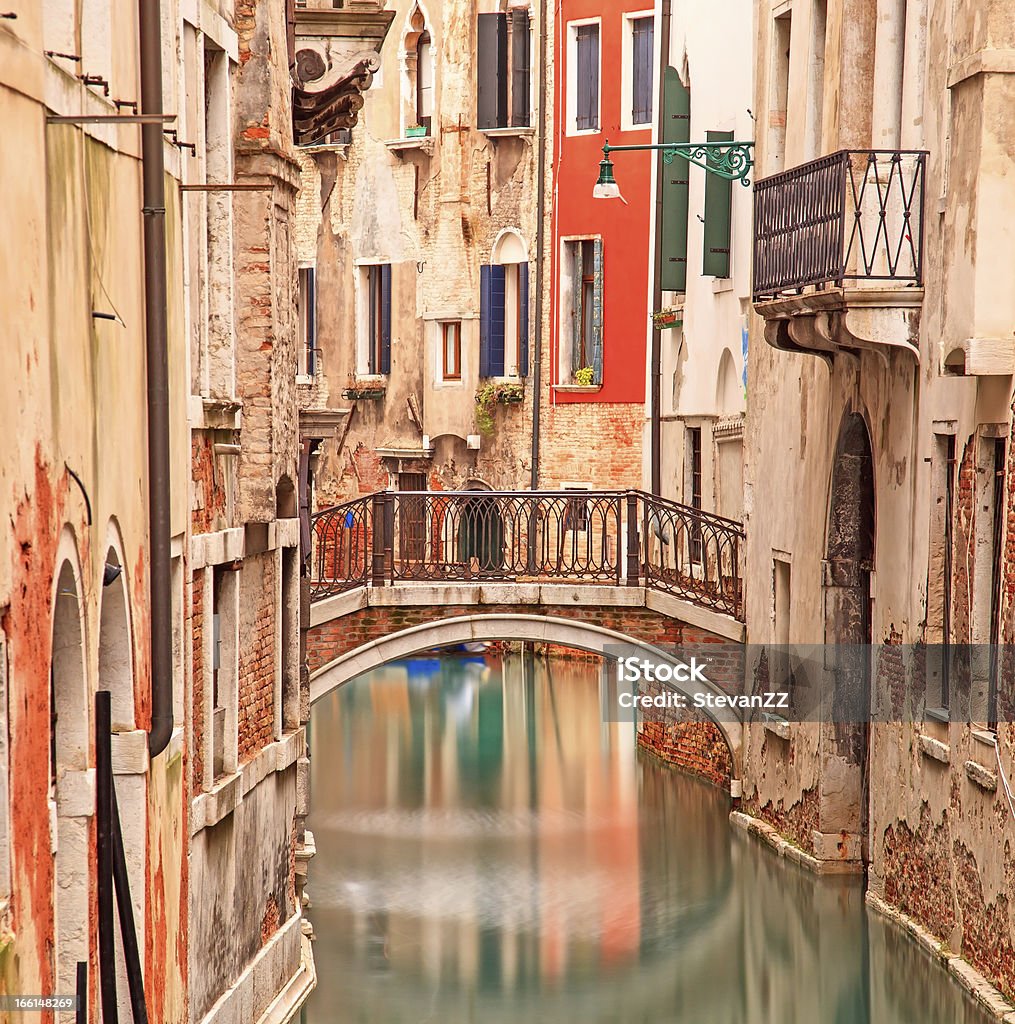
<box><xmin>297</xmin><ymin>2</ymin><xmax>540</xmax><ymax>507</ymax></box>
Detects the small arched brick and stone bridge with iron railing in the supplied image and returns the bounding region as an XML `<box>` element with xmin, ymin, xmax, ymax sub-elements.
<box><xmin>306</xmin><ymin>490</ymin><xmax>745</xmax><ymax>780</ymax></box>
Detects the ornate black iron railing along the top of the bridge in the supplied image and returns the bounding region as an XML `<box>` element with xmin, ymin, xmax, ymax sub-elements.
<box><xmin>309</xmin><ymin>490</ymin><xmax>745</xmax><ymax>618</ymax></box>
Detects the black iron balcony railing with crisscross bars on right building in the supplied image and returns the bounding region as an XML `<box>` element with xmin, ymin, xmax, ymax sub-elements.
<box><xmin>754</xmin><ymin>150</ymin><xmax>927</xmax><ymax>302</ymax></box>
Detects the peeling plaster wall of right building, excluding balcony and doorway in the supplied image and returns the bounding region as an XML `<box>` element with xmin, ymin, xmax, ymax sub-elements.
<box><xmin>745</xmin><ymin>0</ymin><xmax>1015</xmax><ymax>995</ymax></box>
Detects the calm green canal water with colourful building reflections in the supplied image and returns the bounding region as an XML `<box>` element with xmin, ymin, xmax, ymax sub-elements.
<box><xmin>306</xmin><ymin>655</ymin><xmax>987</xmax><ymax>1024</ymax></box>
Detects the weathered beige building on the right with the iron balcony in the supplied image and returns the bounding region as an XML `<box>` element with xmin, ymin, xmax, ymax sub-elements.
<box><xmin>745</xmin><ymin>0</ymin><xmax>1015</xmax><ymax>994</ymax></box>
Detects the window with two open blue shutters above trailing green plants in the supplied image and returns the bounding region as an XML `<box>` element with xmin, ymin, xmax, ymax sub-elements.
<box><xmin>479</xmin><ymin>263</ymin><xmax>528</xmax><ymax>377</ymax></box>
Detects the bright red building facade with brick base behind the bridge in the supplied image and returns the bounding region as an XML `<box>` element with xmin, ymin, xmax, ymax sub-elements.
<box><xmin>541</xmin><ymin>0</ymin><xmax>657</xmax><ymax>487</ymax></box>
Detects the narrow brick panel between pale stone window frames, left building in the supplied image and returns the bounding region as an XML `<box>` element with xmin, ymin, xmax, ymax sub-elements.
<box><xmin>237</xmin><ymin>552</ymin><xmax>281</xmax><ymax>764</ymax></box>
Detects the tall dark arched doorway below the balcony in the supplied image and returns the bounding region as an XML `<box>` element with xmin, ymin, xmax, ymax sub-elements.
<box><xmin>819</xmin><ymin>412</ymin><xmax>876</xmax><ymax>860</ymax></box>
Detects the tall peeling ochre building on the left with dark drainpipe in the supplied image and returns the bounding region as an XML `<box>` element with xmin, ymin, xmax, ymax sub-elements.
<box><xmin>0</xmin><ymin>0</ymin><xmax>314</xmax><ymax>1022</ymax></box>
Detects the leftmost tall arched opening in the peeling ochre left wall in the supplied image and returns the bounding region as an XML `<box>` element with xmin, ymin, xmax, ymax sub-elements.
<box><xmin>49</xmin><ymin>557</ymin><xmax>92</xmax><ymax>1021</ymax></box>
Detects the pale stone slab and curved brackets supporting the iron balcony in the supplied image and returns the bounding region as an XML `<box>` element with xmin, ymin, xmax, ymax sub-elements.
<box><xmin>754</xmin><ymin>288</ymin><xmax>924</xmax><ymax>367</ymax></box>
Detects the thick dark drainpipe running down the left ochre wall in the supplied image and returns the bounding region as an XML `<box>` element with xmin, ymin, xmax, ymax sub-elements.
<box><xmin>137</xmin><ymin>0</ymin><xmax>173</xmax><ymax>758</ymax></box>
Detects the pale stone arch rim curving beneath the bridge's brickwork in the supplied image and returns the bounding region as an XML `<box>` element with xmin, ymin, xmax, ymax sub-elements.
<box><xmin>310</xmin><ymin>612</ymin><xmax>743</xmax><ymax>782</ymax></box>
